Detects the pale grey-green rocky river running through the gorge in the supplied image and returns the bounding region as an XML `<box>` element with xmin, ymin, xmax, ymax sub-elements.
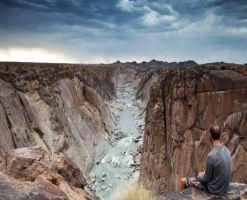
<box><xmin>87</xmin><ymin>80</ymin><xmax>144</xmax><ymax>200</ymax></box>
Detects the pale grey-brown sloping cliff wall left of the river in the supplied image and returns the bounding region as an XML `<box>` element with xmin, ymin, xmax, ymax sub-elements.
<box><xmin>0</xmin><ymin>63</ymin><xmax>115</xmax><ymax>176</ymax></box>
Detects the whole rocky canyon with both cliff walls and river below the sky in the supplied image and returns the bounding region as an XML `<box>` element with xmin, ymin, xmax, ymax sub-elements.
<box><xmin>0</xmin><ymin>60</ymin><xmax>247</xmax><ymax>200</ymax></box>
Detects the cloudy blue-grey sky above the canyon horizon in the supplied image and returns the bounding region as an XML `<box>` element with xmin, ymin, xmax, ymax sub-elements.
<box><xmin>0</xmin><ymin>0</ymin><xmax>247</xmax><ymax>63</ymax></box>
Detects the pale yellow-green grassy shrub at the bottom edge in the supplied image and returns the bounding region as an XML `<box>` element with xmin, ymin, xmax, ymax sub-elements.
<box><xmin>113</xmin><ymin>183</ymin><xmax>155</xmax><ymax>200</ymax></box>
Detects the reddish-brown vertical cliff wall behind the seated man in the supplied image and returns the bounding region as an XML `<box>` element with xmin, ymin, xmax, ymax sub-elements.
<box><xmin>140</xmin><ymin>64</ymin><xmax>247</xmax><ymax>193</ymax></box>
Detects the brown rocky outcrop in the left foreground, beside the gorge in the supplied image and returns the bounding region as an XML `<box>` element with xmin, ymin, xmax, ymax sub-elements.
<box><xmin>0</xmin><ymin>147</ymin><xmax>94</xmax><ymax>200</ymax></box>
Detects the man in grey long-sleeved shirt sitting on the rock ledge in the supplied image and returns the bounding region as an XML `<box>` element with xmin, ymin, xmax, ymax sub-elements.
<box><xmin>179</xmin><ymin>126</ymin><xmax>232</xmax><ymax>195</ymax></box>
